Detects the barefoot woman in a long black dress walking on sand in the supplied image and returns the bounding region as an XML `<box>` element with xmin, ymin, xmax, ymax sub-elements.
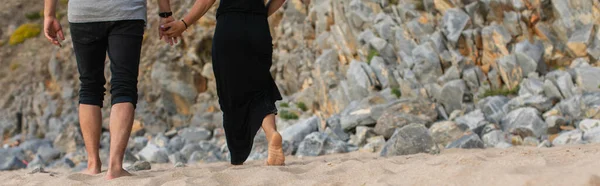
<box><xmin>160</xmin><ymin>0</ymin><xmax>285</xmax><ymax>165</ymax></box>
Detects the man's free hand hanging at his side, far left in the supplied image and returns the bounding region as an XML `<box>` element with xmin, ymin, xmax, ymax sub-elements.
<box><xmin>44</xmin><ymin>0</ymin><xmax>65</xmax><ymax>46</ymax></box>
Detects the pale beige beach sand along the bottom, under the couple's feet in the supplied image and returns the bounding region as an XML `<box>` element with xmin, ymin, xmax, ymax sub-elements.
<box><xmin>0</xmin><ymin>145</ymin><xmax>600</xmax><ymax>186</ymax></box>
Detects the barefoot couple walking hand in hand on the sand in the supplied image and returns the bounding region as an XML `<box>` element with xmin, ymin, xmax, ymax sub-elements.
<box><xmin>44</xmin><ymin>0</ymin><xmax>285</xmax><ymax>179</ymax></box>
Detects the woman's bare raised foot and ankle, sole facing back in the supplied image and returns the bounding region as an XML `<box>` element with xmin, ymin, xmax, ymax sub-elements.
<box><xmin>262</xmin><ymin>114</ymin><xmax>285</xmax><ymax>166</ymax></box>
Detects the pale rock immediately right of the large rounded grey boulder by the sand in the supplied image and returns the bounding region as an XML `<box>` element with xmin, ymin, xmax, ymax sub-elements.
<box><xmin>429</xmin><ymin>121</ymin><xmax>464</xmax><ymax>147</ymax></box>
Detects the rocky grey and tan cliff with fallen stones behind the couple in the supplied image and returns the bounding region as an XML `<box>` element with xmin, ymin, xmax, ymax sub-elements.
<box><xmin>0</xmin><ymin>0</ymin><xmax>600</xmax><ymax>170</ymax></box>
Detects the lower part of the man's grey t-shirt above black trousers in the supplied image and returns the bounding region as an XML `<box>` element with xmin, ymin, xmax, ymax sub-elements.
<box><xmin>68</xmin><ymin>0</ymin><xmax>147</xmax><ymax>23</ymax></box>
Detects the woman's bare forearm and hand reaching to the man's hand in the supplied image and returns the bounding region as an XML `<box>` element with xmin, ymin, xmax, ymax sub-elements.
<box><xmin>161</xmin><ymin>0</ymin><xmax>215</xmax><ymax>37</ymax></box>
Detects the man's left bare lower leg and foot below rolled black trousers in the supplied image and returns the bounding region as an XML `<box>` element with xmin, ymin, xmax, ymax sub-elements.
<box><xmin>79</xmin><ymin>104</ymin><xmax>102</xmax><ymax>175</ymax></box>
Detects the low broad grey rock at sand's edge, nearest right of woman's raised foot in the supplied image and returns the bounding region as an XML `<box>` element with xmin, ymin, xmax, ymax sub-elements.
<box><xmin>296</xmin><ymin>132</ymin><xmax>348</xmax><ymax>156</ymax></box>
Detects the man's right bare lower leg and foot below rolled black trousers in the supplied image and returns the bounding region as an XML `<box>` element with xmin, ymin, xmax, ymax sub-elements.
<box><xmin>106</xmin><ymin>103</ymin><xmax>134</xmax><ymax>180</ymax></box>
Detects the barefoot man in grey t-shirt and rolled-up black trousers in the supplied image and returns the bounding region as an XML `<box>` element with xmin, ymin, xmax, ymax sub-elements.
<box><xmin>44</xmin><ymin>0</ymin><xmax>147</xmax><ymax>180</ymax></box>
